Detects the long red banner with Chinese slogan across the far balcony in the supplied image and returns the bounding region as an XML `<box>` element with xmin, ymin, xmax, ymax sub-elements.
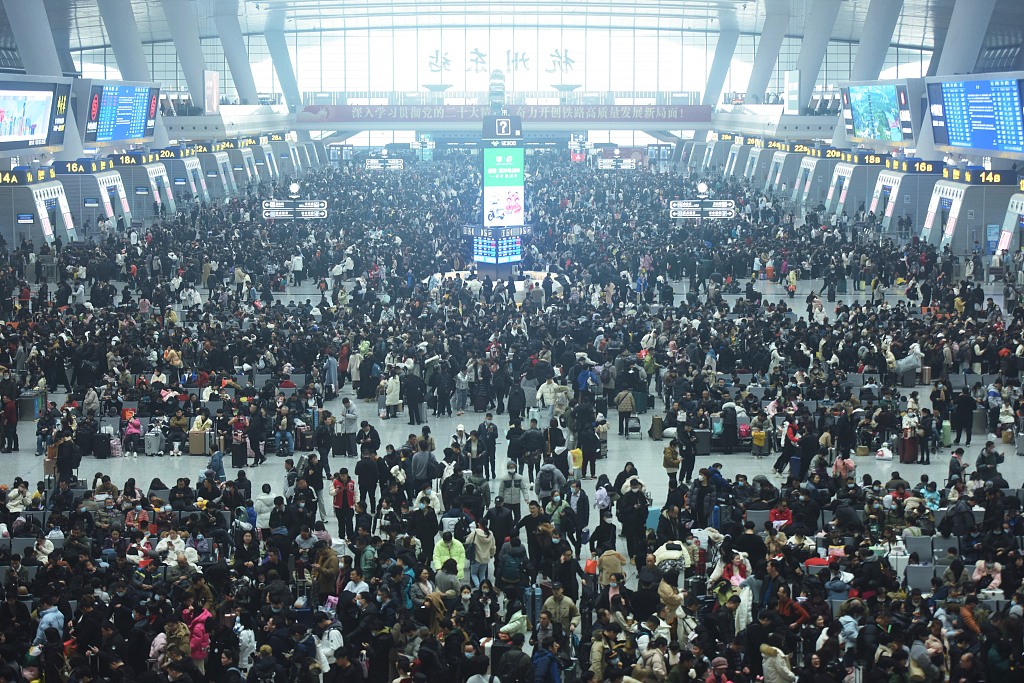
<box><xmin>297</xmin><ymin>104</ymin><xmax>712</xmax><ymax>124</ymax></box>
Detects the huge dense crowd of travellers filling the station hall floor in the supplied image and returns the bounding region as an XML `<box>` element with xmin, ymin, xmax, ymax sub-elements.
<box><xmin>0</xmin><ymin>150</ymin><xmax>1024</xmax><ymax>683</ymax></box>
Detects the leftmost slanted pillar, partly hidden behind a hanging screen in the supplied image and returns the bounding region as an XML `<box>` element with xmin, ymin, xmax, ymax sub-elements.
<box><xmin>3</xmin><ymin>0</ymin><xmax>83</xmax><ymax>161</ymax></box>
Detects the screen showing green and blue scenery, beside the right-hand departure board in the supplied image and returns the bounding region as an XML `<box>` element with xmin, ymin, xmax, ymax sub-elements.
<box><xmin>843</xmin><ymin>83</ymin><xmax>913</xmax><ymax>142</ymax></box>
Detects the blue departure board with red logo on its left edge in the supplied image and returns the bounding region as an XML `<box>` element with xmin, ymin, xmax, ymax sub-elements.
<box><xmin>85</xmin><ymin>85</ymin><xmax>160</xmax><ymax>142</ymax></box>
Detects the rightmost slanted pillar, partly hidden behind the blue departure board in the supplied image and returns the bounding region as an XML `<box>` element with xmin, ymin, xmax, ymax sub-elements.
<box><xmin>916</xmin><ymin>0</ymin><xmax>995</xmax><ymax>160</ymax></box>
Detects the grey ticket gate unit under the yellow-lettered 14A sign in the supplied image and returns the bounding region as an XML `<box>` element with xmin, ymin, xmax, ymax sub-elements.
<box><xmin>0</xmin><ymin>166</ymin><xmax>79</xmax><ymax>245</ymax></box>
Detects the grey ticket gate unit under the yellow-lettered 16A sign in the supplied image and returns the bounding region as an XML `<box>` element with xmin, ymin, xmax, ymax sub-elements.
<box><xmin>51</xmin><ymin>159</ymin><xmax>132</xmax><ymax>229</ymax></box>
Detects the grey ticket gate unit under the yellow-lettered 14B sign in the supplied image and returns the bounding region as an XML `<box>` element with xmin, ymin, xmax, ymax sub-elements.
<box><xmin>921</xmin><ymin>167</ymin><xmax>1017</xmax><ymax>256</ymax></box>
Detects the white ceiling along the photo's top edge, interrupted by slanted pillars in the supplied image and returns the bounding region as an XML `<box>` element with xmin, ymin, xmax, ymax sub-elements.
<box><xmin>18</xmin><ymin>0</ymin><xmax>1024</xmax><ymax>63</ymax></box>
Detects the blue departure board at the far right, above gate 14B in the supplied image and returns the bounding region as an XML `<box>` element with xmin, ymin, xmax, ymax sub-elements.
<box><xmin>928</xmin><ymin>79</ymin><xmax>1024</xmax><ymax>153</ymax></box>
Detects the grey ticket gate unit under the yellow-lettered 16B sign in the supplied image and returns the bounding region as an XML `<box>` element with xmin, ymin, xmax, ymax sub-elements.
<box><xmin>868</xmin><ymin>159</ymin><xmax>942</xmax><ymax>239</ymax></box>
